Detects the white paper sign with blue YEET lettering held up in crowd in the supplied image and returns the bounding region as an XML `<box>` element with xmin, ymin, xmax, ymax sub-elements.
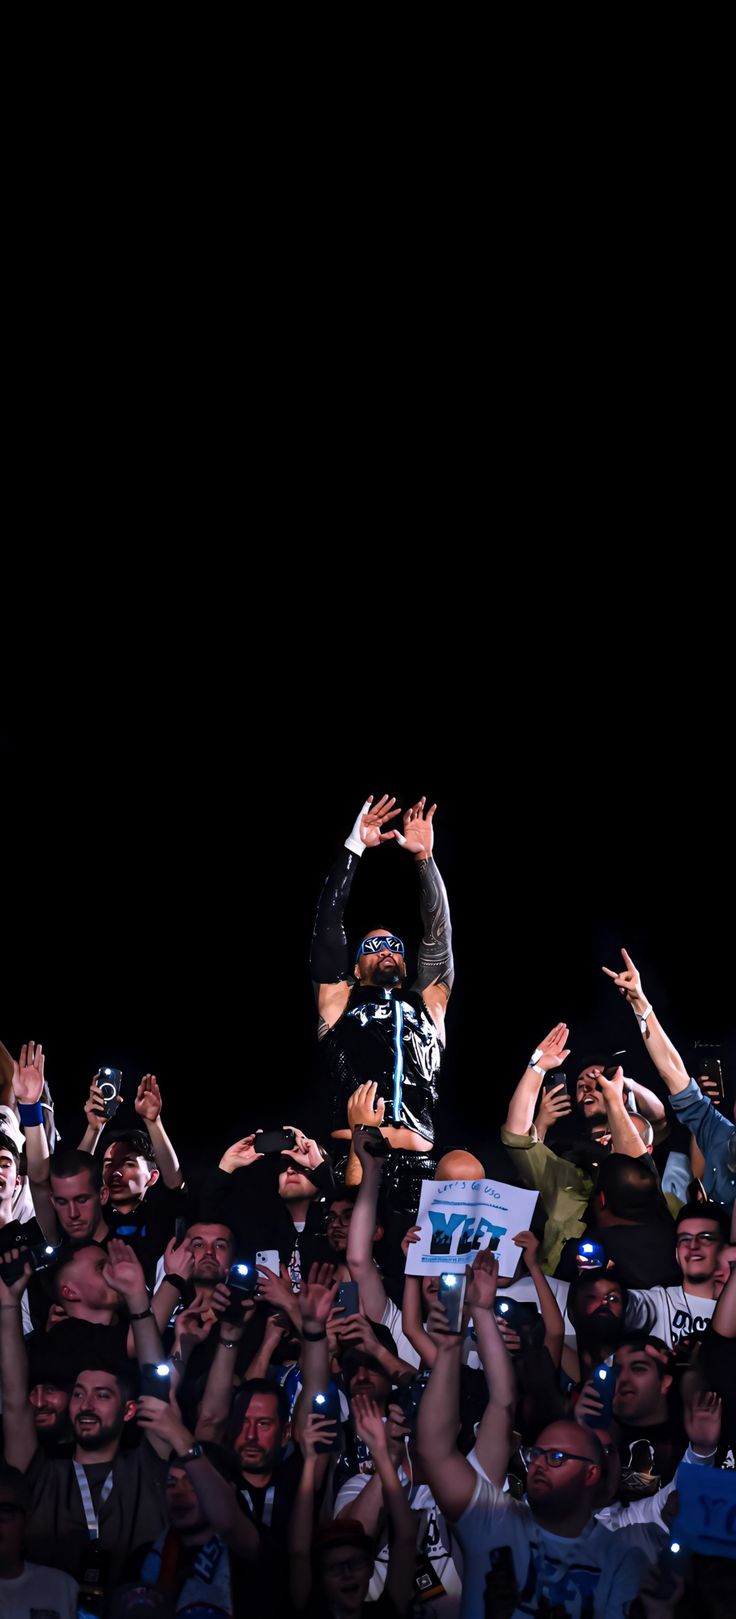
<box><xmin>406</xmin><ymin>1179</ymin><xmax>537</xmax><ymax>1276</ymax></box>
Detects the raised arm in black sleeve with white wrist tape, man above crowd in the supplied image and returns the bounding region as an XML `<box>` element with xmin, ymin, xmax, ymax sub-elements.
<box><xmin>309</xmin><ymin>793</ymin><xmax>398</xmax><ymax>1039</ymax></box>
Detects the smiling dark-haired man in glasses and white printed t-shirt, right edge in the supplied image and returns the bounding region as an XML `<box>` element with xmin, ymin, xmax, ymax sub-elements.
<box><xmin>626</xmin><ymin>1203</ymin><xmax>728</xmax><ymax>1349</ymax></box>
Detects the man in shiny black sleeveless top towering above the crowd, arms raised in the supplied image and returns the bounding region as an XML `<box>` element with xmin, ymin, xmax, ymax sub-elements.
<box><xmin>311</xmin><ymin>795</ymin><xmax>455</xmax><ymax>1211</ymax></box>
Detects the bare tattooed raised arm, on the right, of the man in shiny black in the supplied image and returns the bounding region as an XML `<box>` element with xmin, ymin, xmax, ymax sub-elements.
<box><xmin>403</xmin><ymin>798</ymin><xmax>455</xmax><ymax>1038</ymax></box>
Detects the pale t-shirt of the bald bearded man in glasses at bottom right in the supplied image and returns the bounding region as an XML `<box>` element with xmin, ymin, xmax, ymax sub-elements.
<box><xmin>455</xmin><ymin>1478</ymin><xmax>652</xmax><ymax>1619</ymax></box>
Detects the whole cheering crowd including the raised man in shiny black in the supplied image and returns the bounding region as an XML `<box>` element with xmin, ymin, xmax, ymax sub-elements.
<box><xmin>0</xmin><ymin>795</ymin><xmax>736</xmax><ymax>1619</ymax></box>
